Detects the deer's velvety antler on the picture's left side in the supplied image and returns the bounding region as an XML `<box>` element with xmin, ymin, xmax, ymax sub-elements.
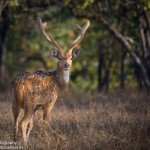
<box><xmin>36</xmin><ymin>17</ymin><xmax>62</xmax><ymax>51</ymax></box>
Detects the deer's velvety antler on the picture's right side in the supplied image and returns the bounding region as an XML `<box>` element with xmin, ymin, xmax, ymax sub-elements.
<box><xmin>68</xmin><ymin>20</ymin><xmax>90</xmax><ymax>51</ymax></box>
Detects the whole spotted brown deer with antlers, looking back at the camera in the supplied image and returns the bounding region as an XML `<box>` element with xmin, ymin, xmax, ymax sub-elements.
<box><xmin>10</xmin><ymin>17</ymin><xmax>90</xmax><ymax>145</ymax></box>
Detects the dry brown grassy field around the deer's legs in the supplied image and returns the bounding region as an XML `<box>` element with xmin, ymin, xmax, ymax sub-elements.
<box><xmin>0</xmin><ymin>91</ymin><xmax>150</xmax><ymax>150</ymax></box>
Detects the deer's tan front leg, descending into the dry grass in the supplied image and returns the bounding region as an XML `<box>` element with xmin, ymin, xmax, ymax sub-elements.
<box><xmin>43</xmin><ymin>97</ymin><xmax>57</xmax><ymax>125</ymax></box>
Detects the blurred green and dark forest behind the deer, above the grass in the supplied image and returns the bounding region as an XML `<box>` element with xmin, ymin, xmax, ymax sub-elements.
<box><xmin>0</xmin><ymin>0</ymin><xmax>150</xmax><ymax>92</ymax></box>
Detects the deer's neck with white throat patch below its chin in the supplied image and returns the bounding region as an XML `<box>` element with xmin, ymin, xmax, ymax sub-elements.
<box><xmin>55</xmin><ymin>69</ymin><xmax>70</xmax><ymax>89</ymax></box>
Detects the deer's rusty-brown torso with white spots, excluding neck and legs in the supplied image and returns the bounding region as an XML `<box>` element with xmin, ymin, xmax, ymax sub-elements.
<box><xmin>11</xmin><ymin>71</ymin><xmax>58</xmax><ymax>108</ymax></box>
